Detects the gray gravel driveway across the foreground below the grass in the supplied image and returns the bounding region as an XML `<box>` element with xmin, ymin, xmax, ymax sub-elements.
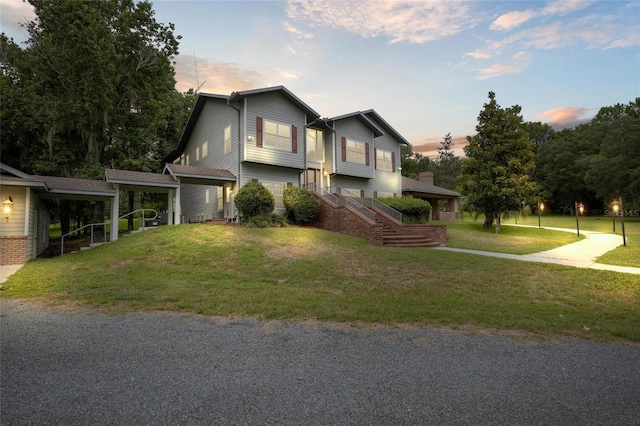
<box><xmin>0</xmin><ymin>300</ymin><xmax>640</xmax><ymax>425</ymax></box>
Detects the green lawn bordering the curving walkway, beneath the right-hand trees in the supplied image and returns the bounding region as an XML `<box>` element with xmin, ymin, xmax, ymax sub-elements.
<box><xmin>442</xmin><ymin>215</ymin><xmax>640</xmax><ymax>268</ymax></box>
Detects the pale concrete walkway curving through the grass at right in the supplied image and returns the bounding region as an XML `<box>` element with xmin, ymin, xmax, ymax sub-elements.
<box><xmin>435</xmin><ymin>225</ymin><xmax>640</xmax><ymax>275</ymax></box>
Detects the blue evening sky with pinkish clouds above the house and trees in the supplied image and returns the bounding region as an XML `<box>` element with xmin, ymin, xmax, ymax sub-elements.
<box><xmin>0</xmin><ymin>0</ymin><xmax>640</xmax><ymax>156</ymax></box>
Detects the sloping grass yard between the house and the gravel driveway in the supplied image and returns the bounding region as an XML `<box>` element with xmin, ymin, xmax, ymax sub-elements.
<box><xmin>0</xmin><ymin>225</ymin><xmax>640</xmax><ymax>342</ymax></box>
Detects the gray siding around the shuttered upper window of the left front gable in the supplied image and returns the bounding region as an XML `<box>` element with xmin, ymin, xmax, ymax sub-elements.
<box><xmin>243</xmin><ymin>93</ymin><xmax>306</xmax><ymax>169</ymax></box>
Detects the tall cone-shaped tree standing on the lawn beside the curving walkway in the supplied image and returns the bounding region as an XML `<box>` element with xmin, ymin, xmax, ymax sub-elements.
<box><xmin>464</xmin><ymin>92</ymin><xmax>536</xmax><ymax>233</ymax></box>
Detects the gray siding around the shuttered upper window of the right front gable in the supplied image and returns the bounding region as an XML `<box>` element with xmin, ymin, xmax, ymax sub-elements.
<box><xmin>334</xmin><ymin>118</ymin><xmax>374</xmax><ymax>178</ymax></box>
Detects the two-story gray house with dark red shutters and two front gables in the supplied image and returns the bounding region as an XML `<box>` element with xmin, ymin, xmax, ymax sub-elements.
<box><xmin>165</xmin><ymin>86</ymin><xmax>408</xmax><ymax>222</ymax></box>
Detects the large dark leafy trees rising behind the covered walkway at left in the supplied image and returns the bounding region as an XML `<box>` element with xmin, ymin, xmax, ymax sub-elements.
<box><xmin>0</xmin><ymin>0</ymin><xmax>195</xmax><ymax>232</ymax></box>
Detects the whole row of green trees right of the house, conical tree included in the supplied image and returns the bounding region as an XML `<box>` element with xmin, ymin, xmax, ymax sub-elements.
<box><xmin>402</xmin><ymin>92</ymin><xmax>640</xmax><ymax>232</ymax></box>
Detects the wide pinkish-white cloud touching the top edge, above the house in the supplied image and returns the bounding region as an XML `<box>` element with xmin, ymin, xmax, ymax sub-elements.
<box><xmin>287</xmin><ymin>0</ymin><xmax>476</xmax><ymax>43</ymax></box>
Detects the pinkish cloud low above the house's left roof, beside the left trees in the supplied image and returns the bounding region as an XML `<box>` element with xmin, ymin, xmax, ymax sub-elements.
<box><xmin>175</xmin><ymin>55</ymin><xmax>268</xmax><ymax>94</ymax></box>
